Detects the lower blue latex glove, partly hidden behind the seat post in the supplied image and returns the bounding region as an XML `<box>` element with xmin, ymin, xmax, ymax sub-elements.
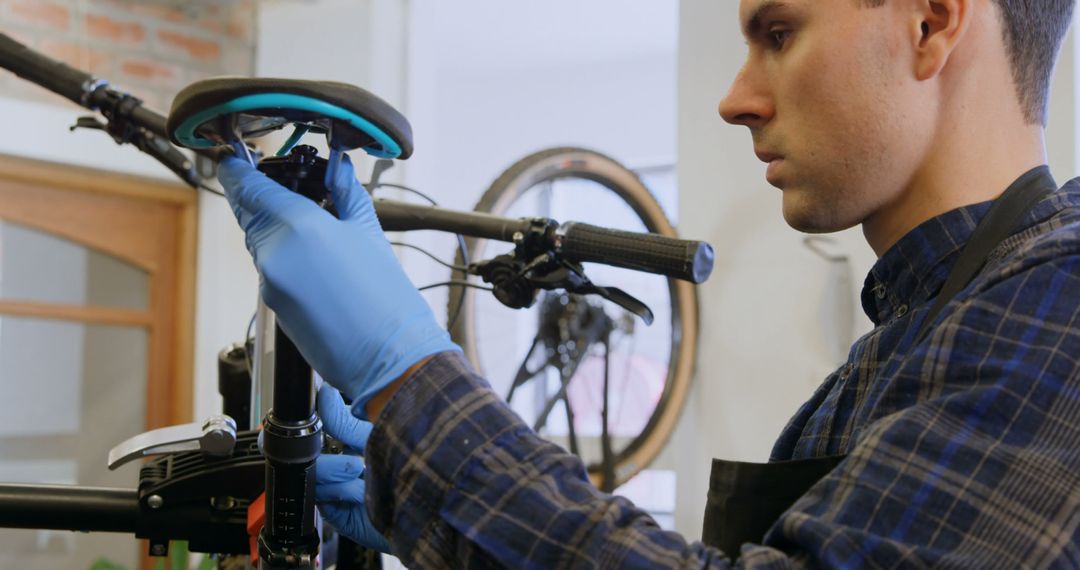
<box><xmin>315</xmin><ymin>384</ymin><xmax>390</xmax><ymax>553</ymax></box>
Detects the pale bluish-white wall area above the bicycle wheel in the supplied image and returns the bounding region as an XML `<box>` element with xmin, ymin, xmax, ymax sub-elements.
<box><xmin>402</xmin><ymin>0</ymin><xmax>677</xmax><ymax>317</ymax></box>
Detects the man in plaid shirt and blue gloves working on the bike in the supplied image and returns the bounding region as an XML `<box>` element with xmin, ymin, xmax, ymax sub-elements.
<box><xmin>220</xmin><ymin>0</ymin><xmax>1080</xmax><ymax>568</ymax></box>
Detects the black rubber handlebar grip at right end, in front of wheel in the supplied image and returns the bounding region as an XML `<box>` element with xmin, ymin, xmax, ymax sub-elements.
<box><xmin>558</xmin><ymin>222</ymin><xmax>714</xmax><ymax>283</ymax></box>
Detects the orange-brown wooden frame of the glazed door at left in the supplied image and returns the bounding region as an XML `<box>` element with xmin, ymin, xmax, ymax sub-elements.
<box><xmin>0</xmin><ymin>154</ymin><xmax>199</xmax><ymax>430</ymax></box>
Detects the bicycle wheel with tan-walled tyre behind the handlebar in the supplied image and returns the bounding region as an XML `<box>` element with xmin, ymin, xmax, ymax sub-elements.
<box><xmin>447</xmin><ymin>148</ymin><xmax>698</xmax><ymax>491</ymax></box>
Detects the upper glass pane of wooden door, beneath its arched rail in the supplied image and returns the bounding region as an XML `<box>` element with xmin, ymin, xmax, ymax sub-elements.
<box><xmin>0</xmin><ymin>221</ymin><xmax>150</xmax><ymax>309</ymax></box>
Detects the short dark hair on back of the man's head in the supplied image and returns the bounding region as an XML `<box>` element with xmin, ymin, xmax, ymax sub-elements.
<box><xmin>862</xmin><ymin>0</ymin><xmax>1076</xmax><ymax>126</ymax></box>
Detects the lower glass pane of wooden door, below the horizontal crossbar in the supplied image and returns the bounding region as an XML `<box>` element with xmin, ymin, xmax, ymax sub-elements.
<box><xmin>0</xmin><ymin>316</ymin><xmax>149</xmax><ymax>570</ymax></box>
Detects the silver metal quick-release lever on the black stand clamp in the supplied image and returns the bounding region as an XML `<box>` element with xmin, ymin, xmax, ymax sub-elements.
<box><xmin>109</xmin><ymin>416</ymin><xmax>237</xmax><ymax>470</ymax></box>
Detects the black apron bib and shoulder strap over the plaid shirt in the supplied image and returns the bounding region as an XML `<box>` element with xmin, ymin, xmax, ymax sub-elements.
<box><xmin>701</xmin><ymin>166</ymin><xmax>1057</xmax><ymax>558</ymax></box>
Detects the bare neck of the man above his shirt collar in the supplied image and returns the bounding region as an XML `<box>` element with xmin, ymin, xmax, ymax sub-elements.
<box><xmin>863</xmin><ymin>125</ymin><xmax>1047</xmax><ymax>257</ymax></box>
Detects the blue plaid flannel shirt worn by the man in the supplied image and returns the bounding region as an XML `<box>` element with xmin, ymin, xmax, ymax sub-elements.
<box><xmin>367</xmin><ymin>175</ymin><xmax>1080</xmax><ymax>568</ymax></box>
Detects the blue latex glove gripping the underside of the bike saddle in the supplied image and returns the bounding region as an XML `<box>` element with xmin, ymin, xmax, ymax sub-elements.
<box><xmin>218</xmin><ymin>153</ymin><xmax>461</xmax><ymax>410</ymax></box>
